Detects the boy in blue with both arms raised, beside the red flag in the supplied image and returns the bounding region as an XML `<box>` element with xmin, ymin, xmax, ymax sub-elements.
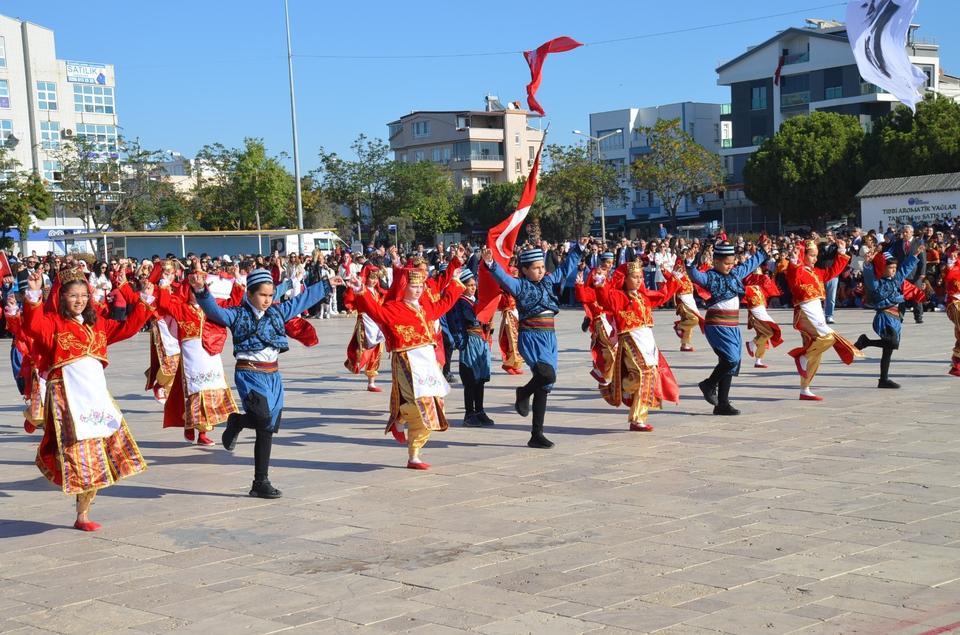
<box><xmin>483</xmin><ymin>238</ymin><xmax>589</xmax><ymax>449</ymax></box>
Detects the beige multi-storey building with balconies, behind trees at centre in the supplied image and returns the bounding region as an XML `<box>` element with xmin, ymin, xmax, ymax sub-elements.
<box><xmin>387</xmin><ymin>96</ymin><xmax>543</xmax><ymax>194</ymax></box>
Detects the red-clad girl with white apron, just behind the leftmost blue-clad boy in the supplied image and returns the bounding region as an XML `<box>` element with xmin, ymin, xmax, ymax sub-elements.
<box><xmin>157</xmin><ymin>285</ymin><xmax>239</xmax><ymax>446</ymax></box>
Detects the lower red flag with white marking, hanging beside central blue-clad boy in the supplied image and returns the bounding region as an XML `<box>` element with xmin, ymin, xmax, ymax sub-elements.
<box><xmin>473</xmin><ymin>142</ymin><xmax>546</xmax><ymax>323</ymax></box>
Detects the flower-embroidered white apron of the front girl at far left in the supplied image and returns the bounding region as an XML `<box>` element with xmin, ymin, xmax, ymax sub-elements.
<box><xmin>60</xmin><ymin>357</ymin><xmax>121</xmax><ymax>441</ymax></box>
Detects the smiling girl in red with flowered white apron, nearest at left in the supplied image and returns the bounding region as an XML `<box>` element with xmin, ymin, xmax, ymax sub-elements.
<box><xmin>23</xmin><ymin>269</ymin><xmax>153</xmax><ymax>531</ymax></box>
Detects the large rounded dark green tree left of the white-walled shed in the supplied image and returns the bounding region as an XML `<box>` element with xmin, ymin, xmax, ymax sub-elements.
<box><xmin>743</xmin><ymin>112</ymin><xmax>864</xmax><ymax>228</ymax></box>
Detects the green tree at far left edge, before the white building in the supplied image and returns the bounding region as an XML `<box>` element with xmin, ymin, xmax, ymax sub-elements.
<box><xmin>0</xmin><ymin>147</ymin><xmax>53</xmax><ymax>249</ymax></box>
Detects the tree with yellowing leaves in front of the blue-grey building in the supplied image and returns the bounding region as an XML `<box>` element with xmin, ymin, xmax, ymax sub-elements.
<box><xmin>631</xmin><ymin>119</ymin><xmax>723</xmax><ymax>230</ymax></box>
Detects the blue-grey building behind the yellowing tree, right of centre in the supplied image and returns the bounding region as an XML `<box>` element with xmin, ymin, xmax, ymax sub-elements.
<box><xmin>590</xmin><ymin>102</ymin><xmax>730</xmax><ymax>236</ymax></box>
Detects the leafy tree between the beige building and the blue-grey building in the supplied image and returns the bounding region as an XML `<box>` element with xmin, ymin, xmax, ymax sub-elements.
<box><xmin>537</xmin><ymin>144</ymin><xmax>624</xmax><ymax>238</ymax></box>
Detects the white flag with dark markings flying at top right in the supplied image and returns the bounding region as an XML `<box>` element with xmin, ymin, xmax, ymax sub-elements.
<box><xmin>847</xmin><ymin>0</ymin><xmax>927</xmax><ymax>112</ymax></box>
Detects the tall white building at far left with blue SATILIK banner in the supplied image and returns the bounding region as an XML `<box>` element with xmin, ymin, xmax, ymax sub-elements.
<box><xmin>0</xmin><ymin>15</ymin><xmax>119</xmax><ymax>253</ymax></box>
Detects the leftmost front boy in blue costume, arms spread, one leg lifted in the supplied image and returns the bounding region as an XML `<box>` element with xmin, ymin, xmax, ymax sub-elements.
<box><xmin>190</xmin><ymin>266</ymin><xmax>343</xmax><ymax>499</ymax></box>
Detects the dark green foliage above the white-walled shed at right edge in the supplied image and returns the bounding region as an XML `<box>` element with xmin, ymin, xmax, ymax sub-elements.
<box><xmin>864</xmin><ymin>96</ymin><xmax>960</xmax><ymax>180</ymax></box>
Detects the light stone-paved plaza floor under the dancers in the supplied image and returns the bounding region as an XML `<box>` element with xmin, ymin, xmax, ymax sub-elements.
<box><xmin>0</xmin><ymin>310</ymin><xmax>960</xmax><ymax>635</ymax></box>
